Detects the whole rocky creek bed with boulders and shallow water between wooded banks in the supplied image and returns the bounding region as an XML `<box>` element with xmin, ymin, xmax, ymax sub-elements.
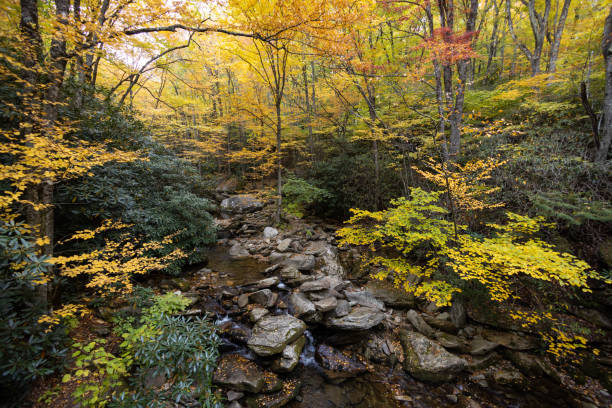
<box><xmin>155</xmin><ymin>195</ymin><xmax>612</xmax><ymax>408</ymax></box>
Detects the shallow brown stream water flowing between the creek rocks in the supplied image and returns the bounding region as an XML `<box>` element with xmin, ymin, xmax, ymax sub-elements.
<box><xmin>191</xmin><ymin>246</ymin><xmax>584</xmax><ymax>408</ymax></box>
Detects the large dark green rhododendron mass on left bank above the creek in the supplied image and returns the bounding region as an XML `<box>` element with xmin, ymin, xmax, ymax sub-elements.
<box><xmin>57</xmin><ymin>152</ymin><xmax>215</xmax><ymax>273</ymax></box>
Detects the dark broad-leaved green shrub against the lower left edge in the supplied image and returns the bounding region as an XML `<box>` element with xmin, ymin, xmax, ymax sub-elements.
<box><xmin>0</xmin><ymin>221</ymin><xmax>67</xmax><ymax>403</ymax></box>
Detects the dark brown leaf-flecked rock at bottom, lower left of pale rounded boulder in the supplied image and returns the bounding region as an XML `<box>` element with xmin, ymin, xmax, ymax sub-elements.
<box><xmin>213</xmin><ymin>354</ymin><xmax>274</xmax><ymax>392</ymax></box>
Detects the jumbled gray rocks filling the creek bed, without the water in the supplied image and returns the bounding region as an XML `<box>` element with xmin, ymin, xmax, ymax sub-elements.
<box><xmin>198</xmin><ymin>197</ymin><xmax>608</xmax><ymax>408</ymax></box>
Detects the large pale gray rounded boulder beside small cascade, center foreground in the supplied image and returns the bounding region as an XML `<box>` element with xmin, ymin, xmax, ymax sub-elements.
<box><xmin>247</xmin><ymin>315</ymin><xmax>306</xmax><ymax>356</ymax></box>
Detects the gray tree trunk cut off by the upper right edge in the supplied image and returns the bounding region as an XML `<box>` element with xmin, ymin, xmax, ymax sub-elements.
<box><xmin>595</xmin><ymin>7</ymin><xmax>612</xmax><ymax>161</ymax></box>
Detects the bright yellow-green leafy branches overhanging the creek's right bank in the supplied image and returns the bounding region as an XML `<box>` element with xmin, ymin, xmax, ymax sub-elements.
<box><xmin>338</xmin><ymin>188</ymin><xmax>609</xmax><ymax>359</ymax></box>
